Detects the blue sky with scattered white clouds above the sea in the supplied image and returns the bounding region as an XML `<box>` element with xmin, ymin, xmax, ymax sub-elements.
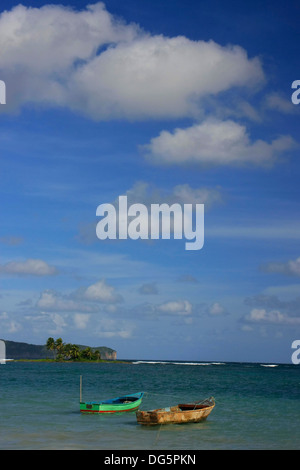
<box><xmin>0</xmin><ymin>0</ymin><xmax>300</xmax><ymax>363</ymax></box>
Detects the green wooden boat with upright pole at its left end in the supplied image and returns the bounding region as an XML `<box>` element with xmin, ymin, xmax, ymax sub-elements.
<box><xmin>80</xmin><ymin>392</ymin><xmax>144</xmax><ymax>413</ymax></box>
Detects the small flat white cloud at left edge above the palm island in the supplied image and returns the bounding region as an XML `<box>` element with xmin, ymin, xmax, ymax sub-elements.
<box><xmin>0</xmin><ymin>258</ymin><xmax>57</xmax><ymax>276</ymax></box>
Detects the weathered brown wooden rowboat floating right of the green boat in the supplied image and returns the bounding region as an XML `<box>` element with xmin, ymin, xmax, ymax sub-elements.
<box><xmin>136</xmin><ymin>397</ymin><xmax>215</xmax><ymax>425</ymax></box>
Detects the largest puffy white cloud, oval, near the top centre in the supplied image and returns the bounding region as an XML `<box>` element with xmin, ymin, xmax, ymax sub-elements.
<box><xmin>71</xmin><ymin>35</ymin><xmax>263</xmax><ymax>119</ymax></box>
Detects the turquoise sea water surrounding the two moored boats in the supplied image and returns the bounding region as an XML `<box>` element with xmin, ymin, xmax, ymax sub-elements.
<box><xmin>0</xmin><ymin>362</ymin><xmax>300</xmax><ymax>450</ymax></box>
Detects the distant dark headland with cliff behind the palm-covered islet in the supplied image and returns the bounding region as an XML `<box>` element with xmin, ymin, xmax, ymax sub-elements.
<box><xmin>3</xmin><ymin>339</ymin><xmax>117</xmax><ymax>360</ymax></box>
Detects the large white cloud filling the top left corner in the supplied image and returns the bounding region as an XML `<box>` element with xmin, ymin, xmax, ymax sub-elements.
<box><xmin>0</xmin><ymin>3</ymin><xmax>130</xmax><ymax>74</ymax></box>
